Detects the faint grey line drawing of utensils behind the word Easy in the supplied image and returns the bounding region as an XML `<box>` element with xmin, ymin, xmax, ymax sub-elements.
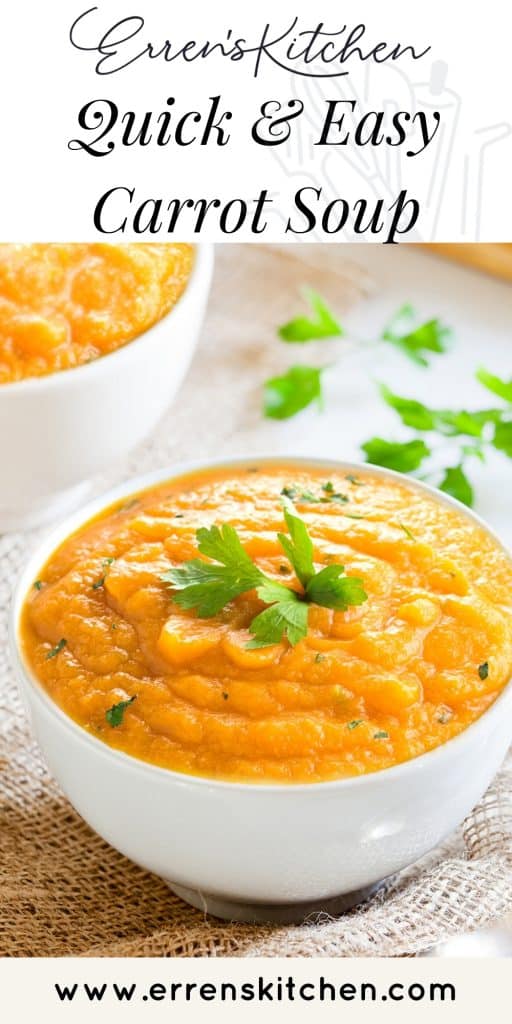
<box><xmin>271</xmin><ymin>60</ymin><xmax>512</xmax><ymax>242</ymax></box>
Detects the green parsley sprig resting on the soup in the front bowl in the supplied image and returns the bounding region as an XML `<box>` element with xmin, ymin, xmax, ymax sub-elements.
<box><xmin>161</xmin><ymin>499</ymin><xmax>368</xmax><ymax>648</ymax></box>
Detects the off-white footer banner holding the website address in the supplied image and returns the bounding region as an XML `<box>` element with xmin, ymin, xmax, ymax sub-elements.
<box><xmin>0</xmin><ymin>957</ymin><xmax>510</xmax><ymax>1024</ymax></box>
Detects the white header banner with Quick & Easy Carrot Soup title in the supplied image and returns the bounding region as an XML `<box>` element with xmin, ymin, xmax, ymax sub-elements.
<box><xmin>0</xmin><ymin>0</ymin><xmax>512</xmax><ymax>243</ymax></box>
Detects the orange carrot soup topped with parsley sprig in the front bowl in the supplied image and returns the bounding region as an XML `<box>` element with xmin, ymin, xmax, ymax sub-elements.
<box><xmin>23</xmin><ymin>464</ymin><xmax>512</xmax><ymax>782</ymax></box>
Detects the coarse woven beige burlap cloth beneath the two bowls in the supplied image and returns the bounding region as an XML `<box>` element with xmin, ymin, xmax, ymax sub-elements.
<box><xmin>0</xmin><ymin>246</ymin><xmax>512</xmax><ymax>956</ymax></box>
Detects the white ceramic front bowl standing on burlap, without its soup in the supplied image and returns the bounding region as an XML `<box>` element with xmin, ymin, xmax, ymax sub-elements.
<box><xmin>10</xmin><ymin>457</ymin><xmax>512</xmax><ymax>921</ymax></box>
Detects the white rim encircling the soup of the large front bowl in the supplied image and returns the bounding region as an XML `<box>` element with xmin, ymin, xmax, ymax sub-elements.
<box><xmin>8</xmin><ymin>453</ymin><xmax>512</xmax><ymax>794</ymax></box>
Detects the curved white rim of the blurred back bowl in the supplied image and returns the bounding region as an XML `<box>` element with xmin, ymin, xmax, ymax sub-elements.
<box><xmin>0</xmin><ymin>242</ymin><xmax>214</xmax><ymax>400</ymax></box>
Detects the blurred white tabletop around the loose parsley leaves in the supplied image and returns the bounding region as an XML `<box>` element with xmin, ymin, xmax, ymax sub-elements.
<box><xmin>272</xmin><ymin>245</ymin><xmax>512</xmax><ymax>544</ymax></box>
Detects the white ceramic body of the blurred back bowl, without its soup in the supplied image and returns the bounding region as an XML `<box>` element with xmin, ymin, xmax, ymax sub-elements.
<box><xmin>0</xmin><ymin>245</ymin><xmax>213</xmax><ymax>532</ymax></box>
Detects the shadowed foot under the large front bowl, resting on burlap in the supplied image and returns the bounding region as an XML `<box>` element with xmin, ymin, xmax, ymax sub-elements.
<box><xmin>168</xmin><ymin>880</ymin><xmax>384</xmax><ymax>925</ymax></box>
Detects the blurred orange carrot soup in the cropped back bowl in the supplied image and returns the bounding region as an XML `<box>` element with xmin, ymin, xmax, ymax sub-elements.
<box><xmin>0</xmin><ymin>243</ymin><xmax>194</xmax><ymax>384</ymax></box>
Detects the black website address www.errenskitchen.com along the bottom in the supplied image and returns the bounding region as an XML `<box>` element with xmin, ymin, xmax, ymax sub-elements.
<box><xmin>53</xmin><ymin>975</ymin><xmax>457</xmax><ymax>1005</ymax></box>
